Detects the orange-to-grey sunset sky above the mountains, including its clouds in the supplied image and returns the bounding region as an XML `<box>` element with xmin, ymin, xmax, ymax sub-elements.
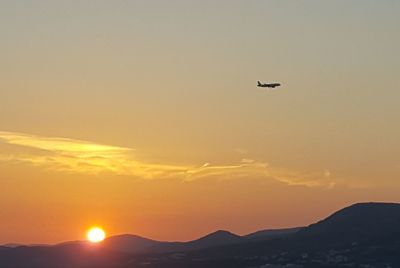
<box><xmin>0</xmin><ymin>0</ymin><xmax>400</xmax><ymax>243</ymax></box>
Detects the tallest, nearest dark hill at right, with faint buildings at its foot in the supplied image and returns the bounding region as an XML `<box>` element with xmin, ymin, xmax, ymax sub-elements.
<box><xmin>183</xmin><ymin>203</ymin><xmax>400</xmax><ymax>268</ymax></box>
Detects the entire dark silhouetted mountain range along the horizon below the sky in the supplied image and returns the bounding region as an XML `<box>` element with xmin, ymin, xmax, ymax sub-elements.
<box><xmin>0</xmin><ymin>203</ymin><xmax>400</xmax><ymax>268</ymax></box>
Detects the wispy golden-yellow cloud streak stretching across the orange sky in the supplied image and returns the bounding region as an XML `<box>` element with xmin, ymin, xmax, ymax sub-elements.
<box><xmin>0</xmin><ymin>131</ymin><xmax>335</xmax><ymax>187</ymax></box>
